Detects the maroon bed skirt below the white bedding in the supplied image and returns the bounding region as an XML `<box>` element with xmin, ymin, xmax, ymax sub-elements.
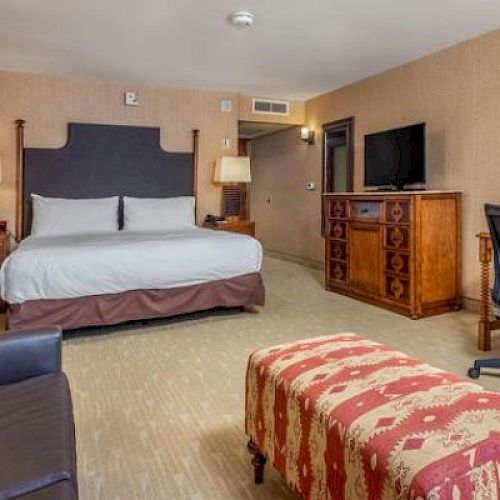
<box><xmin>7</xmin><ymin>273</ymin><xmax>265</xmax><ymax>330</ymax></box>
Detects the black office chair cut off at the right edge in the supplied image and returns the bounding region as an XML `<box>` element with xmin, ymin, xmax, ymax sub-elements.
<box><xmin>469</xmin><ymin>203</ymin><xmax>500</xmax><ymax>378</ymax></box>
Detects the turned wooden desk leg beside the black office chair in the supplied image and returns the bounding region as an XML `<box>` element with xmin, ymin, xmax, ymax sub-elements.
<box><xmin>477</xmin><ymin>233</ymin><xmax>491</xmax><ymax>351</ymax></box>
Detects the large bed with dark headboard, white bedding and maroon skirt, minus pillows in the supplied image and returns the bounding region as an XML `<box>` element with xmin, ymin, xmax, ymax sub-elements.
<box><xmin>6</xmin><ymin>120</ymin><xmax>264</xmax><ymax>329</ymax></box>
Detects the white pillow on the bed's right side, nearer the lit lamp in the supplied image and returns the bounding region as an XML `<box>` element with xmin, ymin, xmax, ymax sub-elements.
<box><xmin>123</xmin><ymin>196</ymin><xmax>196</xmax><ymax>231</ymax></box>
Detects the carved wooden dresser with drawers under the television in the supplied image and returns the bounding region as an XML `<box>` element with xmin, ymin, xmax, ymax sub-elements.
<box><xmin>324</xmin><ymin>191</ymin><xmax>461</xmax><ymax>319</ymax></box>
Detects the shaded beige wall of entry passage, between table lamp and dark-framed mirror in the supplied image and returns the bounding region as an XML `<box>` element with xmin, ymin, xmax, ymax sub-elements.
<box><xmin>250</xmin><ymin>127</ymin><xmax>323</xmax><ymax>260</ymax></box>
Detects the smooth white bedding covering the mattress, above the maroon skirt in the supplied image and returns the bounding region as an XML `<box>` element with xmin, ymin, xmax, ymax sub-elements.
<box><xmin>0</xmin><ymin>228</ymin><xmax>262</xmax><ymax>304</ymax></box>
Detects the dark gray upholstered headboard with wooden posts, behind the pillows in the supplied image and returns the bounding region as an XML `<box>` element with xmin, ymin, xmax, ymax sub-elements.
<box><xmin>20</xmin><ymin>123</ymin><xmax>198</xmax><ymax>237</ymax></box>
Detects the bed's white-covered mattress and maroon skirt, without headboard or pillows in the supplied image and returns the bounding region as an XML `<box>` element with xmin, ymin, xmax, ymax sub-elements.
<box><xmin>0</xmin><ymin>228</ymin><xmax>264</xmax><ymax>329</ymax></box>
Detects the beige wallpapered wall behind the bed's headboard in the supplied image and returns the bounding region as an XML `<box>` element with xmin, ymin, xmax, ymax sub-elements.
<box><xmin>0</xmin><ymin>71</ymin><xmax>239</xmax><ymax>229</ymax></box>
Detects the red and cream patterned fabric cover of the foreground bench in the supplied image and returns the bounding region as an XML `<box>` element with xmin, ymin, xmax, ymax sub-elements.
<box><xmin>246</xmin><ymin>334</ymin><xmax>500</xmax><ymax>500</ymax></box>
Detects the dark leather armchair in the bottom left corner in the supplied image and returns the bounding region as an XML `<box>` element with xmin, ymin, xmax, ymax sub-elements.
<box><xmin>0</xmin><ymin>327</ymin><xmax>78</xmax><ymax>500</ymax></box>
